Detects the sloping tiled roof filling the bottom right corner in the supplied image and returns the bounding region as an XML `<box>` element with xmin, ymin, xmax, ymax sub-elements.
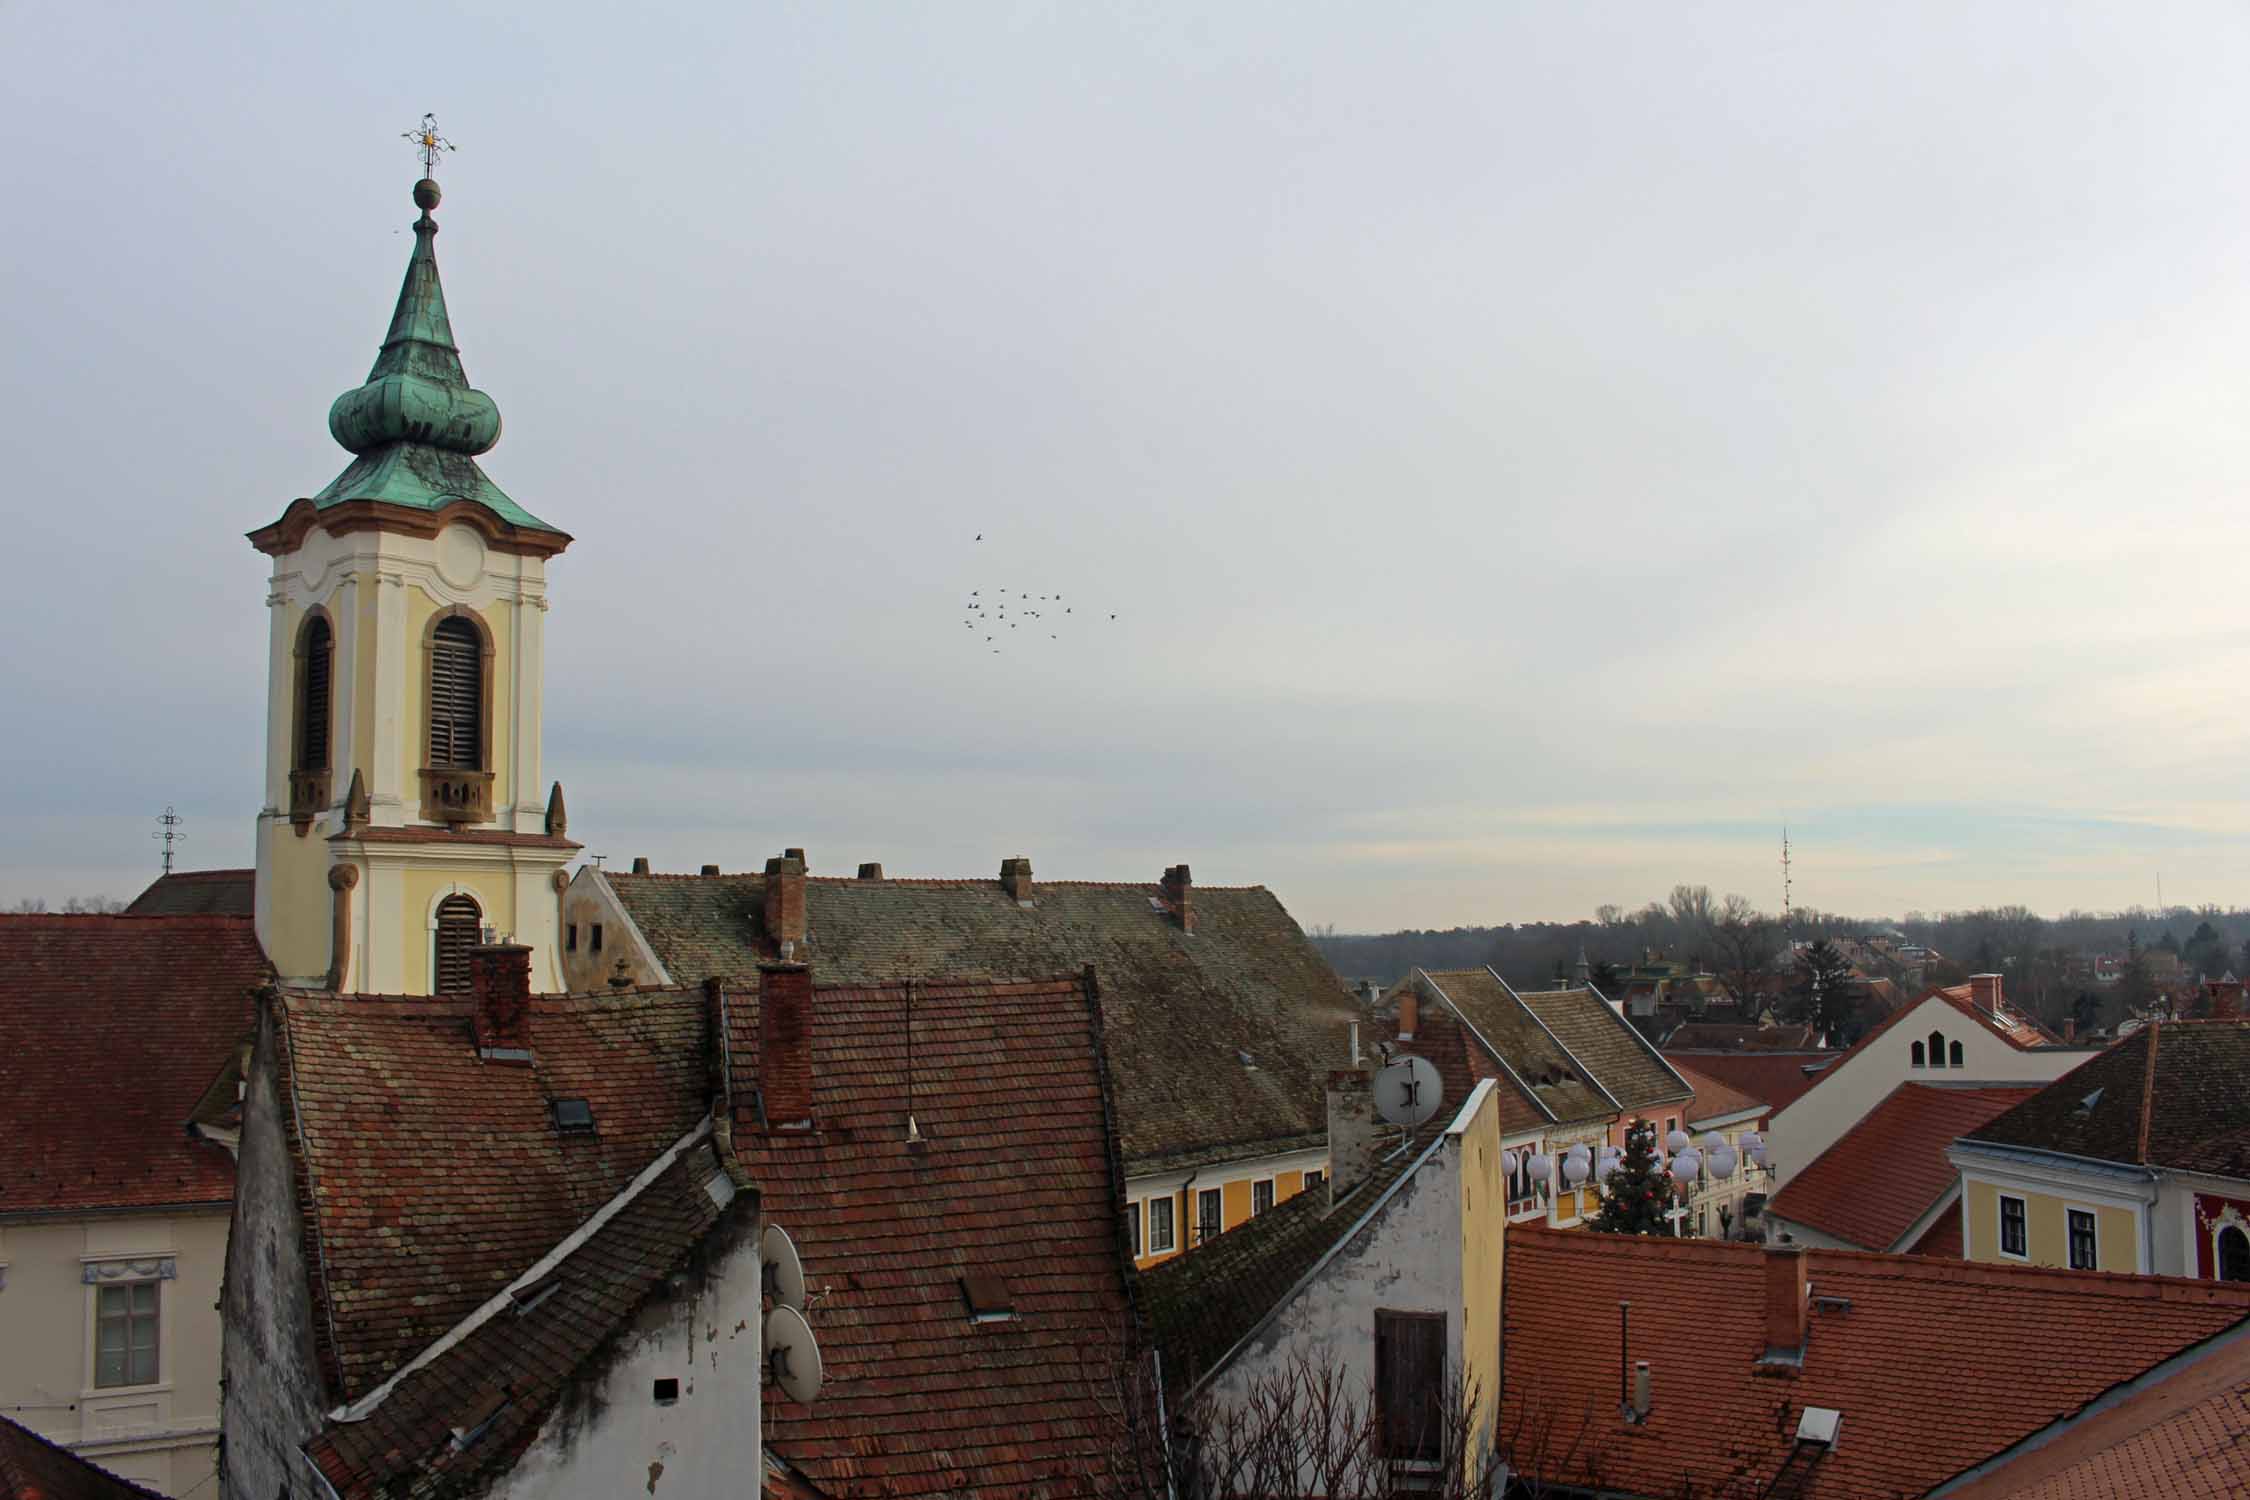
<box><xmin>1935</xmin><ymin>1325</ymin><xmax>2250</xmax><ymax>1500</ymax></box>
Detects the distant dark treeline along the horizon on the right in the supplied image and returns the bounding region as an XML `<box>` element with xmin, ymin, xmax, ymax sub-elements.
<box><xmin>1312</xmin><ymin>886</ymin><xmax>2250</xmax><ymax>1001</ymax></box>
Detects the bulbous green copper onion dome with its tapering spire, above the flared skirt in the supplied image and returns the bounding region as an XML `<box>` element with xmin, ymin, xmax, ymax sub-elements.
<box><xmin>329</xmin><ymin>178</ymin><xmax>500</xmax><ymax>454</ymax></box>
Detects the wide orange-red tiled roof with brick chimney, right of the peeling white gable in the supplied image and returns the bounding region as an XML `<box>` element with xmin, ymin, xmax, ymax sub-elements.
<box><xmin>1503</xmin><ymin>1226</ymin><xmax>2250</xmax><ymax>1500</ymax></box>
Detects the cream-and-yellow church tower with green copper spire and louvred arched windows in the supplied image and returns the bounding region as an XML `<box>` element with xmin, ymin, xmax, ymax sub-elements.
<box><xmin>250</xmin><ymin>167</ymin><xmax>578</xmax><ymax>994</ymax></box>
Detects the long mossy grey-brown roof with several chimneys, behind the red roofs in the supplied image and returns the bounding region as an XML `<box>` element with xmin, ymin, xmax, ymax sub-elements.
<box><xmin>608</xmin><ymin>873</ymin><xmax>1359</xmax><ymax>1172</ymax></box>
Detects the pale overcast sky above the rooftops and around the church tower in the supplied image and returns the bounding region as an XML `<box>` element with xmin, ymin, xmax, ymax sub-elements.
<box><xmin>0</xmin><ymin>0</ymin><xmax>2250</xmax><ymax>929</ymax></box>
